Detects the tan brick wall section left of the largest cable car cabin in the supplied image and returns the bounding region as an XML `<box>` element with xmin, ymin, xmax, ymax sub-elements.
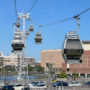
<box><xmin>41</xmin><ymin>50</ymin><xmax>65</xmax><ymax>71</ymax></box>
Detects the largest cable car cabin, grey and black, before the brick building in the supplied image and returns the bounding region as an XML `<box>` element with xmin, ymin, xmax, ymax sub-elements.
<box><xmin>63</xmin><ymin>34</ymin><xmax>84</xmax><ymax>64</ymax></box>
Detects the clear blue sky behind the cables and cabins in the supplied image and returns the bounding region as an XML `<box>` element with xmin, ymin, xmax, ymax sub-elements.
<box><xmin>0</xmin><ymin>0</ymin><xmax>90</xmax><ymax>61</ymax></box>
